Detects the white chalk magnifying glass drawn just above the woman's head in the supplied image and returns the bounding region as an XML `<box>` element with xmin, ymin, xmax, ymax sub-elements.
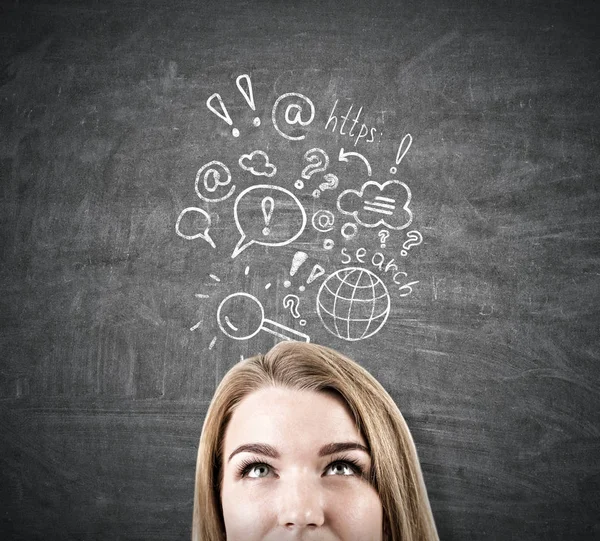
<box><xmin>217</xmin><ymin>292</ymin><xmax>310</xmax><ymax>342</ymax></box>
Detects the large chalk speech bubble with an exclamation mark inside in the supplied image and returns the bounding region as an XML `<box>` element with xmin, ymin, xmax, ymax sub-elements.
<box><xmin>231</xmin><ymin>184</ymin><xmax>307</xmax><ymax>258</ymax></box>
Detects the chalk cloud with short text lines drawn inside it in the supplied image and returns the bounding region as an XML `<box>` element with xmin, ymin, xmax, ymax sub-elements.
<box><xmin>337</xmin><ymin>180</ymin><xmax>413</xmax><ymax>230</ymax></box>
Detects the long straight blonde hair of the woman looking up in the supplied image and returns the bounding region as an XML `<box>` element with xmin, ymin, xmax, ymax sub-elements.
<box><xmin>192</xmin><ymin>342</ymin><xmax>439</xmax><ymax>541</ymax></box>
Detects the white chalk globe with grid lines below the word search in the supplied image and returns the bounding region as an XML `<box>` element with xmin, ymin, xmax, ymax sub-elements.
<box><xmin>317</xmin><ymin>267</ymin><xmax>390</xmax><ymax>341</ymax></box>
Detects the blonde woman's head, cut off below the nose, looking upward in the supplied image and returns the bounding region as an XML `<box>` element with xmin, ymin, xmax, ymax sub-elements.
<box><xmin>193</xmin><ymin>342</ymin><xmax>437</xmax><ymax>541</ymax></box>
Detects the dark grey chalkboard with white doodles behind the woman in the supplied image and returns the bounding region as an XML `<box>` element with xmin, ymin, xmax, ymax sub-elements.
<box><xmin>0</xmin><ymin>0</ymin><xmax>600</xmax><ymax>541</ymax></box>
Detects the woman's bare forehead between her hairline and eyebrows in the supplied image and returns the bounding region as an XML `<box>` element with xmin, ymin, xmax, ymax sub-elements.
<box><xmin>224</xmin><ymin>387</ymin><xmax>365</xmax><ymax>454</ymax></box>
